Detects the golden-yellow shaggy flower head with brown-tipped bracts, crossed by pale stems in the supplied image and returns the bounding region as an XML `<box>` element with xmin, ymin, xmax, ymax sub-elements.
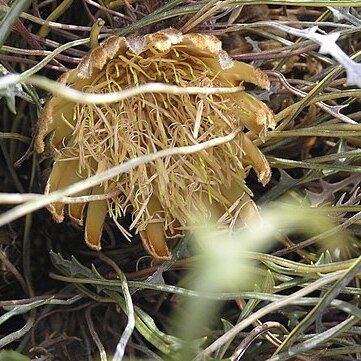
<box><xmin>35</xmin><ymin>29</ymin><xmax>275</xmax><ymax>258</ymax></box>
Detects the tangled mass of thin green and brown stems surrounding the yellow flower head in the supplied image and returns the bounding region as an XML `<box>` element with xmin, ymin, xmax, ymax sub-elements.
<box><xmin>0</xmin><ymin>0</ymin><xmax>361</xmax><ymax>361</ymax></box>
